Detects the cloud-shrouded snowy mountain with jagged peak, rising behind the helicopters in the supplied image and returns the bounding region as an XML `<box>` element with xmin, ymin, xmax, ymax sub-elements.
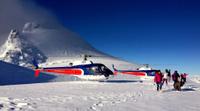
<box><xmin>0</xmin><ymin>0</ymin><xmax>139</xmax><ymax>69</ymax></box>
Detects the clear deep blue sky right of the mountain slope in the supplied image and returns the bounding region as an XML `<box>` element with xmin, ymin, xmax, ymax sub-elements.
<box><xmin>36</xmin><ymin>0</ymin><xmax>200</xmax><ymax>74</ymax></box>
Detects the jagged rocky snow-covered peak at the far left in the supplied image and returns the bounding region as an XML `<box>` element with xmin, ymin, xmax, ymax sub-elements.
<box><xmin>0</xmin><ymin>30</ymin><xmax>47</xmax><ymax>66</ymax></box>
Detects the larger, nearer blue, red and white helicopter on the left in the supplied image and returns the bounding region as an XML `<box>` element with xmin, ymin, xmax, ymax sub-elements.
<box><xmin>33</xmin><ymin>56</ymin><xmax>113</xmax><ymax>80</ymax></box>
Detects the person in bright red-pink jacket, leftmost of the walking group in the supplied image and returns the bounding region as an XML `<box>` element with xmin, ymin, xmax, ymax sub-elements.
<box><xmin>154</xmin><ymin>70</ymin><xmax>163</xmax><ymax>91</ymax></box>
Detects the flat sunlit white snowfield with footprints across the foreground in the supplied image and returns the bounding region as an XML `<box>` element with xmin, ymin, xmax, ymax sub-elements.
<box><xmin>0</xmin><ymin>76</ymin><xmax>200</xmax><ymax>111</ymax></box>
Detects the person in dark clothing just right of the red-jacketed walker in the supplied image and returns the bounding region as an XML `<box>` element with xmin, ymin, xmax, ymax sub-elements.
<box><xmin>172</xmin><ymin>71</ymin><xmax>181</xmax><ymax>91</ymax></box>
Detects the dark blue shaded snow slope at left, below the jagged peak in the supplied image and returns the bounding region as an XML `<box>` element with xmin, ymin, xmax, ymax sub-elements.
<box><xmin>0</xmin><ymin>61</ymin><xmax>56</xmax><ymax>85</ymax></box>
